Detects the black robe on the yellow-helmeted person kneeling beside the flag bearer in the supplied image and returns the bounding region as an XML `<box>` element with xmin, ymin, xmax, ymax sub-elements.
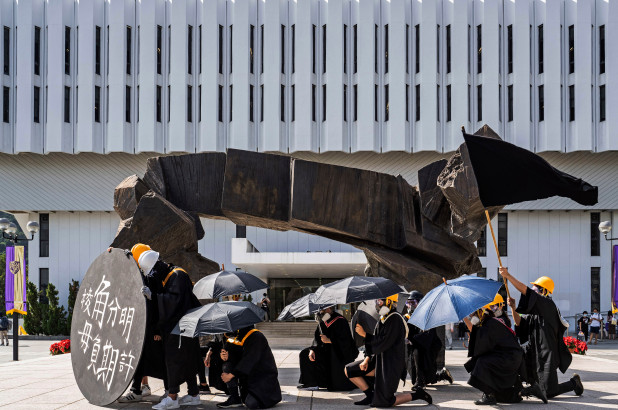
<box><xmin>464</xmin><ymin>317</ymin><xmax>523</xmax><ymax>403</ymax></box>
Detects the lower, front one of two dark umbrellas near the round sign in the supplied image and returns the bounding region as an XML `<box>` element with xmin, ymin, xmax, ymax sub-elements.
<box><xmin>172</xmin><ymin>302</ymin><xmax>266</xmax><ymax>337</ymax></box>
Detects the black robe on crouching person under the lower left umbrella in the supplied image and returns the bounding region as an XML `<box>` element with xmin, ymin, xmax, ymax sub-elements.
<box><xmin>232</xmin><ymin>328</ymin><xmax>281</xmax><ymax>409</ymax></box>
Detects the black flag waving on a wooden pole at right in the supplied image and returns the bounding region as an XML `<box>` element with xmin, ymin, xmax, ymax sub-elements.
<box><xmin>464</xmin><ymin>133</ymin><xmax>598</xmax><ymax>207</ymax></box>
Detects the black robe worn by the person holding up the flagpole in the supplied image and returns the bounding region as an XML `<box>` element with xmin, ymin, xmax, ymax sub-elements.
<box><xmin>515</xmin><ymin>288</ymin><xmax>573</xmax><ymax>398</ymax></box>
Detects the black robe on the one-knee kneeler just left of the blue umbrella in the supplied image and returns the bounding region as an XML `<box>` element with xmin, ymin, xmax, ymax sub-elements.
<box><xmin>365</xmin><ymin>309</ymin><xmax>407</xmax><ymax>407</ymax></box>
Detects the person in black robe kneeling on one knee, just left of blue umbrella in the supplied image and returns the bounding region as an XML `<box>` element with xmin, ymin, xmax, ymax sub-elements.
<box><xmin>346</xmin><ymin>298</ymin><xmax>432</xmax><ymax>407</ymax></box>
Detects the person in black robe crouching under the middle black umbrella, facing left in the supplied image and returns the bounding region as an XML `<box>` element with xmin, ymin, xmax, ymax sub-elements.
<box><xmin>298</xmin><ymin>307</ymin><xmax>358</xmax><ymax>391</ymax></box>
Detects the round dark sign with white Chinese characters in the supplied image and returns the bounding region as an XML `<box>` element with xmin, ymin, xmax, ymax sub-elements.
<box><xmin>71</xmin><ymin>248</ymin><xmax>146</xmax><ymax>406</ymax></box>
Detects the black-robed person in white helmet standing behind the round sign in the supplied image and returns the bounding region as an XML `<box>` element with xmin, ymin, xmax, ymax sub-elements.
<box><xmin>138</xmin><ymin>250</ymin><xmax>201</xmax><ymax>410</ymax></box>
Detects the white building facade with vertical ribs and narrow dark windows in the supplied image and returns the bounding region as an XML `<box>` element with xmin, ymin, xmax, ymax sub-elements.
<box><xmin>0</xmin><ymin>0</ymin><xmax>618</xmax><ymax>315</ymax></box>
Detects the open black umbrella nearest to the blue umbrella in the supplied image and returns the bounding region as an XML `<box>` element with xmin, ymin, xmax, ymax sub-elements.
<box><xmin>313</xmin><ymin>276</ymin><xmax>405</xmax><ymax>305</ymax></box>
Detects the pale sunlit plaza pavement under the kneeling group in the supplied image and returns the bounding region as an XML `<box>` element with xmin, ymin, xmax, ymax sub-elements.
<box><xmin>0</xmin><ymin>340</ymin><xmax>618</xmax><ymax>410</ymax></box>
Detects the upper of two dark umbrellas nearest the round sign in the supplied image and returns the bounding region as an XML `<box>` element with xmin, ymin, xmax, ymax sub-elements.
<box><xmin>193</xmin><ymin>270</ymin><xmax>268</xmax><ymax>299</ymax></box>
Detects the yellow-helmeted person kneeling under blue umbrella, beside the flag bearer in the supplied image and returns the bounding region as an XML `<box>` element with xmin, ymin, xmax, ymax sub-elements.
<box><xmin>464</xmin><ymin>294</ymin><xmax>547</xmax><ymax>405</ymax></box>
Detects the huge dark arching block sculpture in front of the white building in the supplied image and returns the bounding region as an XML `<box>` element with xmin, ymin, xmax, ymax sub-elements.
<box><xmin>111</xmin><ymin>127</ymin><xmax>501</xmax><ymax>291</ymax></box>
